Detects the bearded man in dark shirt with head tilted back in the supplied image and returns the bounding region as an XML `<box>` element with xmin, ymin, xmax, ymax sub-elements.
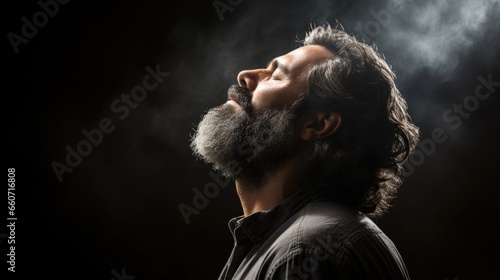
<box><xmin>191</xmin><ymin>25</ymin><xmax>419</xmax><ymax>280</ymax></box>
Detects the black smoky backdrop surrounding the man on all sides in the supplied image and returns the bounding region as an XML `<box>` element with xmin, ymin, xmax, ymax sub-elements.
<box><xmin>0</xmin><ymin>0</ymin><xmax>500</xmax><ymax>280</ymax></box>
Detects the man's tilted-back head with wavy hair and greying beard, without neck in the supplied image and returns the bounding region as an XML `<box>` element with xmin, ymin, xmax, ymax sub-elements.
<box><xmin>191</xmin><ymin>23</ymin><xmax>418</xmax><ymax>216</ymax></box>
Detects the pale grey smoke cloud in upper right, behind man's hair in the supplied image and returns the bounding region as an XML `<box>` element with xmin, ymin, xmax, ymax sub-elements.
<box><xmin>356</xmin><ymin>0</ymin><xmax>499</xmax><ymax>124</ymax></box>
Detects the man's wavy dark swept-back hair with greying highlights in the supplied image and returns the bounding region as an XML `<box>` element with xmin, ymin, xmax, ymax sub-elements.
<box><xmin>297</xmin><ymin>24</ymin><xmax>419</xmax><ymax>217</ymax></box>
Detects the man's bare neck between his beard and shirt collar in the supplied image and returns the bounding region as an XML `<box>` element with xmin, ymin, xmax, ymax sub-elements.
<box><xmin>236</xmin><ymin>158</ymin><xmax>307</xmax><ymax>217</ymax></box>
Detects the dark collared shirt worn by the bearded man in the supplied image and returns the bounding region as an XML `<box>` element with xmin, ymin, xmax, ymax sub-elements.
<box><xmin>219</xmin><ymin>187</ymin><xmax>410</xmax><ymax>280</ymax></box>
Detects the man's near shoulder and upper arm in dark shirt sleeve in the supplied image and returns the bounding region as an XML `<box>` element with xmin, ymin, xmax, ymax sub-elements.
<box><xmin>262</xmin><ymin>200</ymin><xmax>407</xmax><ymax>279</ymax></box>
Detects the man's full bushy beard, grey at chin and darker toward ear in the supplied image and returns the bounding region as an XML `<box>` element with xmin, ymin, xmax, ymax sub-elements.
<box><xmin>190</xmin><ymin>101</ymin><xmax>295</xmax><ymax>189</ymax></box>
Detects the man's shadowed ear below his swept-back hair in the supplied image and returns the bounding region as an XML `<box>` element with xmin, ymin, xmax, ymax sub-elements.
<box><xmin>299</xmin><ymin>110</ymin><xmax>342</xmax><ymax>142</ymax></box>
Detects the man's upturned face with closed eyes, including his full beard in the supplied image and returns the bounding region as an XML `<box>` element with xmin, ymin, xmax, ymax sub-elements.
<box><xmin>191</xmin><ymin>45</ymin><xmax>334</xmax><ymax>187</ymax></box>
